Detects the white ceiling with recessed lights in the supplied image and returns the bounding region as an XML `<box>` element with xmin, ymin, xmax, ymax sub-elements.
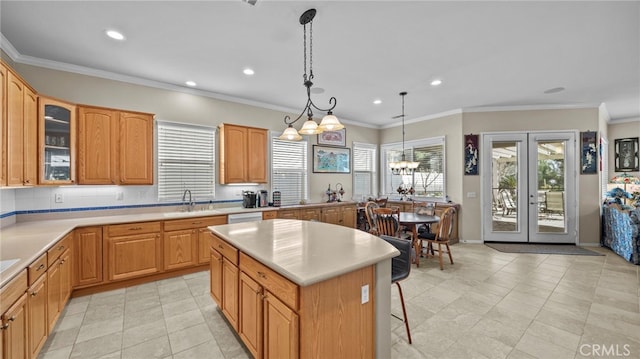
<box><xmin>0</xmin><ymin>0</ymin><xmax>640</xmax><ymax>128</ymax></box>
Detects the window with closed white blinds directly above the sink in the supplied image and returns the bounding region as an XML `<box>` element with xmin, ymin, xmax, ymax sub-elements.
<box><xmin>158</xmin><ymin>122</ymin><xmax>215</xmax><ymax>201</ymax></box>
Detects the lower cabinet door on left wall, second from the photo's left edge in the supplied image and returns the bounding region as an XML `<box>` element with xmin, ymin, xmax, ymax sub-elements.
<box><xmin>27</xmin><ymin>274</ymin><xmax>49</xmax><ymax>358</ymax></box>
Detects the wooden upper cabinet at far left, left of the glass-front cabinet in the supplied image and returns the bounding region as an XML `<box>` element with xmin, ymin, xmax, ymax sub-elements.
<box><xmin>2</xmin><ymin>67</ymin><xmax>38</xmax><ymax>186</ymax></box>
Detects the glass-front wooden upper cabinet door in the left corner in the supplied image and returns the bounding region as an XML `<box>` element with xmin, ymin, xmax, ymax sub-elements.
<box><xmin>38</xmin><ymin>97</ymin><xmax>76</xmax><ymax>184</ymax></box>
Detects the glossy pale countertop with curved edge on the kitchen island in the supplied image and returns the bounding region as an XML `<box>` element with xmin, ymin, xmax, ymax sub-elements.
<box><xmin>208</xmin><ymin>219</ymin><xmax>400</xmax><ymax>287</ymax></box>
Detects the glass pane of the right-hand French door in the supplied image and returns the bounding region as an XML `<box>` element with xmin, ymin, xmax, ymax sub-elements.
<box><xmin>537</xmin><ymin>140</ymin><xmax>566</xmax><ymax>233</ymax></box>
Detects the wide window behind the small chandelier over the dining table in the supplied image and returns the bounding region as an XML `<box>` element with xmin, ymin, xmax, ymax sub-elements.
<box><xmin>380</xmin><ymin>137</ymin><xmax>446</xmax><ymax>200</ymax></box>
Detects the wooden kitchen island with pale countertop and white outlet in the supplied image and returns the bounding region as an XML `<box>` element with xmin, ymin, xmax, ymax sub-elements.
<box><xmin>208</xmin><ymin>219</ymin><xmax>399</xmax><ymax>358</ymax></box>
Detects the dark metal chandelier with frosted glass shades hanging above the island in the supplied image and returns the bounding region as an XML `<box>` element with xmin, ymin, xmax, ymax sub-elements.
<box><xmin>278</xmin><ymin>9</ymin><xmax>344</xmax><ymax>141</ymax></box>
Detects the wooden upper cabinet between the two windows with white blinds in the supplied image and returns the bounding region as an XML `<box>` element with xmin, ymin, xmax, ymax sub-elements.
<box><xmin>220</xmin><ymin>123</ymin><xmax>268</xmax><ymax>184</ymax></box>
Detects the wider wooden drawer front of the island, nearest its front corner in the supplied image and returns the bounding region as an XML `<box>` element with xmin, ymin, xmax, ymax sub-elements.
<box><xmin>240</xmin><ymin>253</ymin><xmax>298</xmax><ymax>311</ymax></box>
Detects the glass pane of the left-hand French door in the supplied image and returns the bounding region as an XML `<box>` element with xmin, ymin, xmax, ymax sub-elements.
<box><xmin>491</xmin><ymin>141</ymin><xmax>520</xmax><ymax>232</ymax></box>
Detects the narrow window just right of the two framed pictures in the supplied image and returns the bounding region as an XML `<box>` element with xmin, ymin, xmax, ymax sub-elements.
<box><xmin>353</xmin><ymin>142</ymin><xmax>378</xmax><ymax>200</ymax></box>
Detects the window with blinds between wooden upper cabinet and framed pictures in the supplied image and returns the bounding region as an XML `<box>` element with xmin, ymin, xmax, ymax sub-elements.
<box><xmin>271</xmin><ymin>137</ymin><xmax>308</xmax><ymax>205</ymax></box>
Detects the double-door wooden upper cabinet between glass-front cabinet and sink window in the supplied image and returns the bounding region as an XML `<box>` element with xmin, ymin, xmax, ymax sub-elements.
<box><xmin>78</xmin><ymin>106</ymin><xmax>153</xmax><ymax>185</ymax></box>
